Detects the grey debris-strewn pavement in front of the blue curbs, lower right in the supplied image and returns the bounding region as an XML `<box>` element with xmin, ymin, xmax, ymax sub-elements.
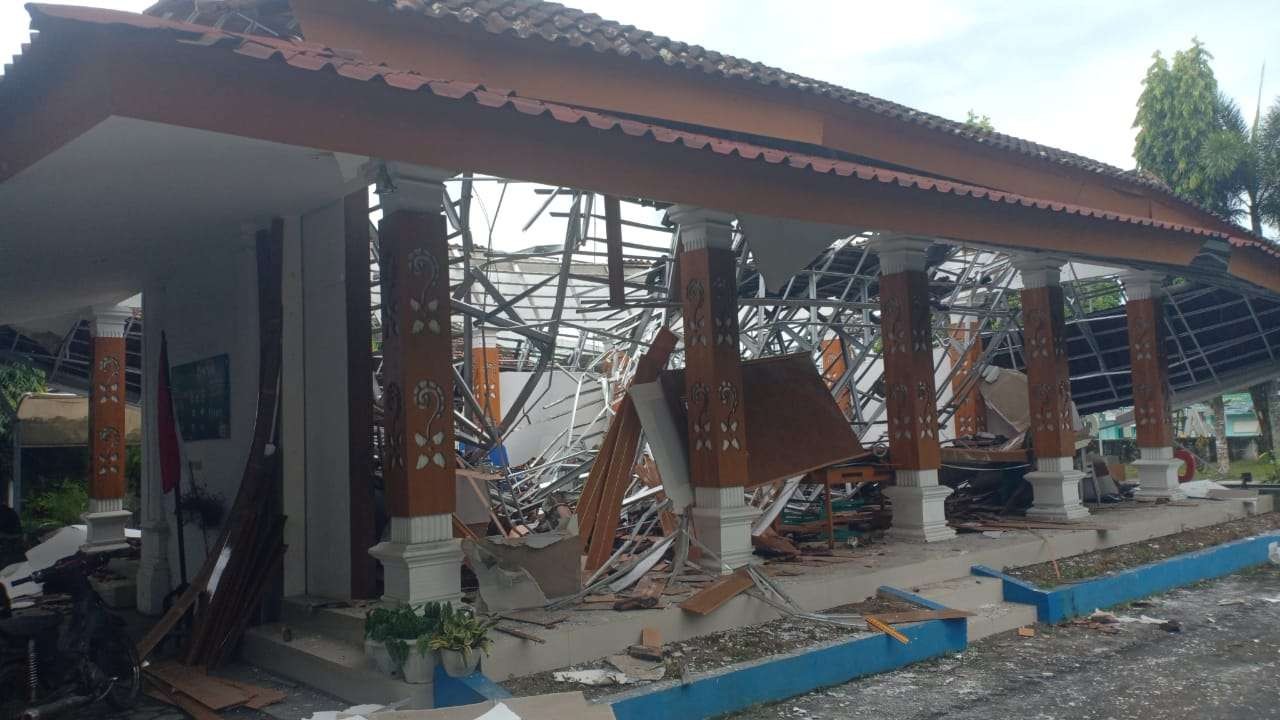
<box><xmin>733</xmin><ymin>566</ymin><xmax>1280</xmax><ymax>720</ymax></box>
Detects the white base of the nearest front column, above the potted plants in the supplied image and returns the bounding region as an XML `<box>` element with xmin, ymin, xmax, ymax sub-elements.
<box><xmin>369</xmin><ymin>512</ymin><xmax>462</xmax><ymax>605</ymax></box>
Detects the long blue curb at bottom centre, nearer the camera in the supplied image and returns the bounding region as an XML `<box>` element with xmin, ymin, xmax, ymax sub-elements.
<box><xmin>608</xmin><ymin>587</ymin><xmax>969</xmax><ymax>720</ymax></box>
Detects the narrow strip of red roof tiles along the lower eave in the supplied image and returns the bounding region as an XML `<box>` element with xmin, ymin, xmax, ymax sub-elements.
<box><xmin>0</xmin><ymin>4</ymin><xmax>1280</xmax><ymax>256</ymax></box>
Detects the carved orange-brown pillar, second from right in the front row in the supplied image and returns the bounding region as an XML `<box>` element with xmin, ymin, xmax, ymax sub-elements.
<box><xmin>1014</xmin><ymin>255</ymin><xmax>1089</xmax><ymax>520</ymax></box>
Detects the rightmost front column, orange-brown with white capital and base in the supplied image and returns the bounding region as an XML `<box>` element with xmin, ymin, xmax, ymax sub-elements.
<box><xmin>1124</xmin><ymin>272</ymin><xmax>1187</xmax><ymax>501</ymax></box>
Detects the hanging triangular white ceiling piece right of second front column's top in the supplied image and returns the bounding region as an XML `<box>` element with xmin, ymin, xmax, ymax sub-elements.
<box><xmin>737</xmin><ymin>214</ymin><xmax>858</xmax><ymax>292</ymax></box>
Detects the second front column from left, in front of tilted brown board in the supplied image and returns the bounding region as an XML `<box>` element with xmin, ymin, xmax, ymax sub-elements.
<box><xmin>667</xmin><ymin>205</ymin><xmax>756</xmax><ymax>573</ymax></box>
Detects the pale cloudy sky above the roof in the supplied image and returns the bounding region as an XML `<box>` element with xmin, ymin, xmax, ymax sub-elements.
<box><xmin>0</xmin><ymin>0</ymin><xmax>1280</xmax><ymax>168</ymax></box>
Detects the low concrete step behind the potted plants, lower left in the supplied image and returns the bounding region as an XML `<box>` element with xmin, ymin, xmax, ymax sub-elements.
<box><xmin>241</xmin><ymin>623</ymin><xmax>434</xmax><ymax>708</ymax></box>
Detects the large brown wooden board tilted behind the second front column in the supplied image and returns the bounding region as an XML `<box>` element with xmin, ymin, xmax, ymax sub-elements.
<box><xmin>662</xmin><ymin>354</ymin><xmax>867</xmax><ymax>487</ymax></box>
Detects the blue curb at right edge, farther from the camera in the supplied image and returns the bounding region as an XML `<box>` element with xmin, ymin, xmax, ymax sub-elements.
<box><xmin>972</xmin><ymin>533</ymin><xmax>1280</xmax><ymax>624</ymax></box>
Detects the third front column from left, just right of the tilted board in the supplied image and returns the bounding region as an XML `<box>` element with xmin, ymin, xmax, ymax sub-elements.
<box><xmin>876</xmin><ymin>237</ymin><xmax>955</xmax><ymax>542</ymax></box>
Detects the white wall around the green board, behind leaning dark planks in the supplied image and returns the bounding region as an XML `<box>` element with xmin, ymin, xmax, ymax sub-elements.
<box><xmin>140</xmin><ymin>201</ymin><xmax>351</xmax><ymax>607</ymax></box>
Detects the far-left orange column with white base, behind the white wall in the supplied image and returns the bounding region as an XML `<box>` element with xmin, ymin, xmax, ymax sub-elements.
<box><xmin>82</xmin><ymin>306</ymin><xmax>133</xmax><ymax>551</ymax></box>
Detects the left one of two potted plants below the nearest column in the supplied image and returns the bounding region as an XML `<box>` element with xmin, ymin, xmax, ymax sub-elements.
<box><xmin>365</xmin><ymin>602</ymin><xmax>448</xmax><ymax>683</ymax></box>
